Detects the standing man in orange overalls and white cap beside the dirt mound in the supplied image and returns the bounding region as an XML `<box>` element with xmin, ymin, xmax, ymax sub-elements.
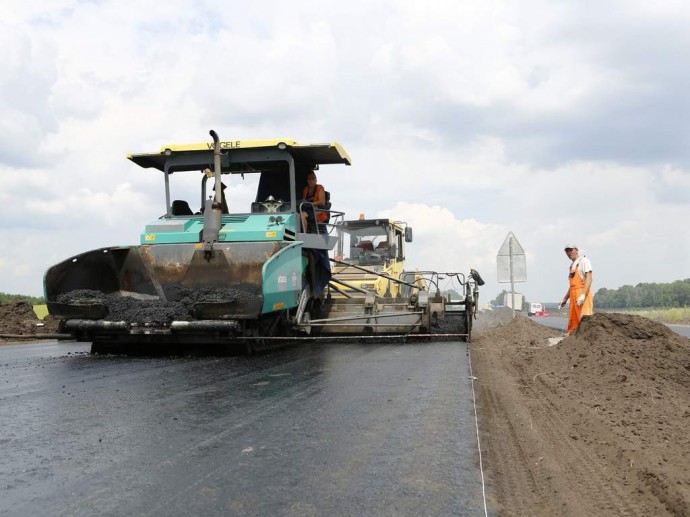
<box><xmin>558</xmin><ymin>244</ymin><xmax>594</xmax><ymax>334</ymax></box>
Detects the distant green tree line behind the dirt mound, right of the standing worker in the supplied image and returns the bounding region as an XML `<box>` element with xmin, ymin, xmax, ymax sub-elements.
<box><xmin>594</xmin><ymin>278</ymin><xmax>690</xmax><ymax>309</ymax></box>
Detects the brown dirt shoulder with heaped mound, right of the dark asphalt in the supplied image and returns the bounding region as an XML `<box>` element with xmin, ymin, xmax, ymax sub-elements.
<box><xmin>470</xmin><ymin>313</ymin><xmax>690</xmax><ymax>516</ymax></box>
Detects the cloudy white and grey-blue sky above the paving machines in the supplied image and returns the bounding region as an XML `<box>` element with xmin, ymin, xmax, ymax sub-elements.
<box><xmin>0</xmin><ymin>0</ymin><xmax>690</xmax><ymax>302</ymax></box>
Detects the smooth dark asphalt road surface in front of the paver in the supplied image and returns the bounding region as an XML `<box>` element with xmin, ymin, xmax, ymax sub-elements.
<box><xmin>0</xmin><ymin>342</ymin><xmax>484</xmax><ymax>516</ymax></box>
